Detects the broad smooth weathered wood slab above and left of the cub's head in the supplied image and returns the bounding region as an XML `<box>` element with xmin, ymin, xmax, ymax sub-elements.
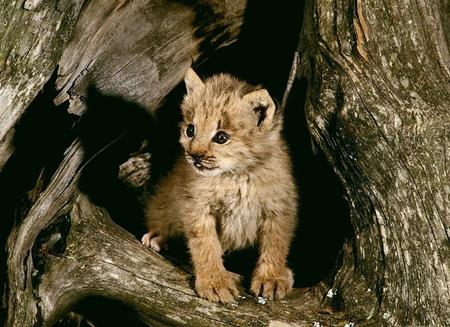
<box><xmin>56</xmin><ymin>0</ymin><xmax>246</xmax><ymax>113</ymax></box>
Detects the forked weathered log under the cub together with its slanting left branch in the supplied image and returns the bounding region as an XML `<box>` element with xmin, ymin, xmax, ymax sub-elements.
<box><xmin>8</xmin><ymin>142</ymin><xmax>351</xmax><ymax>326</ymax></box>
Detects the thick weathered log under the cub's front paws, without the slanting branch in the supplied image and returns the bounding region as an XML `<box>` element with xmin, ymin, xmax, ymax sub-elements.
<box><xmin>38</xmin><ymin>195</ymin><xmax>346</xmax><ymax>326</ymax></box>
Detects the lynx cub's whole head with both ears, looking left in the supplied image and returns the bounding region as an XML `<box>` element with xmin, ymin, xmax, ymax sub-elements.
<box><xmin>180</xmin><ymin>69</ymin><xmax>278</xmax><ymax>176</ymax></box>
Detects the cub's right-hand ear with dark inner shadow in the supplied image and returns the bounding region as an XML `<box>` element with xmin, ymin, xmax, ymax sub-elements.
<box><xmin>243</xmin><ymin>89</ymin><xmax>275</xmax><ymax>127</ymax></box>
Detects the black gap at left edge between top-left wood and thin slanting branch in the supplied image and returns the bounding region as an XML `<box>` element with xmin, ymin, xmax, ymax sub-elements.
<box><xmin>0</xmin><ymin>71</ymin><xmax>75</xmax><ymax>325</ymax></box>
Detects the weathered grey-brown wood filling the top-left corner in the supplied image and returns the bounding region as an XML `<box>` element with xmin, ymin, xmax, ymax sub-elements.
<box><xmin>0</xmin><ymin>0</ymin><xmax>84</xmax><ymax>170</ymax></box>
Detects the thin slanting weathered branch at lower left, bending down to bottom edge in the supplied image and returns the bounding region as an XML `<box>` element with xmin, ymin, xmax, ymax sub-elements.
<box><xmin>7</xmin><ymin>142</ymin><xmax>83</xmax><ymax>326</ymax></box>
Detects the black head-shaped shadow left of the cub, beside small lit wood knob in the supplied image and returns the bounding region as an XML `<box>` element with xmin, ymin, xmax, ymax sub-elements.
<box><xmin>76</xmin><ymin>87</ymin><xmax>153</xmax><ymax>237</ymax></box>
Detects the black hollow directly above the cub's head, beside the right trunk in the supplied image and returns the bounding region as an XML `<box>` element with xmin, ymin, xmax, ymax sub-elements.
<box><xmin>197</xmin><ymin>0</ymin><xmax>304</xmax><ymax>99</ymax></box>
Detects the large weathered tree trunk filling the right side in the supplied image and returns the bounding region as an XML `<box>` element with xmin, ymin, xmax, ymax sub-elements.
<box><xmin>301</xmin><ymin>0</ymin><xmax>450</xmax><ymax>326</ymax></box>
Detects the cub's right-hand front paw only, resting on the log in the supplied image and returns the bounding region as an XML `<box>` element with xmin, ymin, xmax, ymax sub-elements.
<box><xmin>251</xmin><ymin>265</ymin><xmax>294</xmax><ymax>300</ymax></box>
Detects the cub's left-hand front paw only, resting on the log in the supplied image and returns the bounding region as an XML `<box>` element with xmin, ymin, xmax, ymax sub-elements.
<box><xmin>195</xmin><ymin>270</ymin><xmax>239</xmax><ymax>303</ymax></box>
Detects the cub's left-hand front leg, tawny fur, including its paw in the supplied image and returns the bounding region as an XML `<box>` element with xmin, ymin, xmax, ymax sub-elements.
<box><xmin>186</xmin><ymin>214</ymin><xmax>239</xmax><ymax>303</ymax></box>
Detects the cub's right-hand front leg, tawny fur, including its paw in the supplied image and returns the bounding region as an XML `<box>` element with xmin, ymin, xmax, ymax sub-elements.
<box><xmin>251</xmin><ymin>210</ymin><xmax>296</xmax><ymax>300</ymax></box>
